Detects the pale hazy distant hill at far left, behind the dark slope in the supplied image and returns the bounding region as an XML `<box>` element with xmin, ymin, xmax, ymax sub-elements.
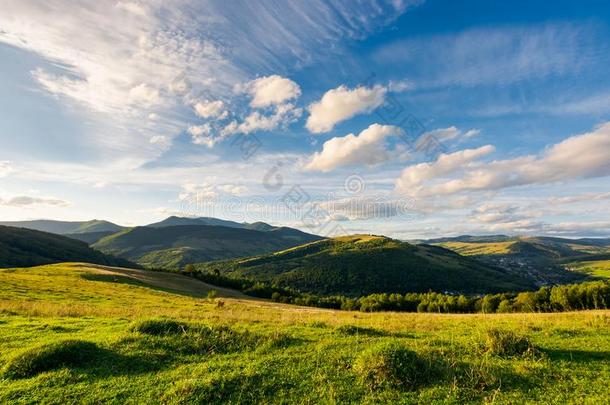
<box><xmin>0</xmin><ymin>219</ymin><xmax>124</xmax><ymax>235</ymax></box>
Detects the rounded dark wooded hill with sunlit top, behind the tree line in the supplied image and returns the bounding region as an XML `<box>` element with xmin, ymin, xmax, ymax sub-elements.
<box><xmin>198</xmin><ymin>235</ymin><xmax>533</xmax><ymax>296</ymax></box>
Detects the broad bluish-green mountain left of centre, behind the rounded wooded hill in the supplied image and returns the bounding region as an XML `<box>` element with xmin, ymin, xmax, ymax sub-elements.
<box><xmin>93</xmin><ymin>225</ymin><xmax>320</xmax><ymax>269</ymax></box>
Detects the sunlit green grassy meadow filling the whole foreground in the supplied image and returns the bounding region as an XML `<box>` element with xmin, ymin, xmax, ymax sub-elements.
<box><xmin>0</xmin><ymin>264</ymin><xmax>610</xmax><ymax>404</ymax></box>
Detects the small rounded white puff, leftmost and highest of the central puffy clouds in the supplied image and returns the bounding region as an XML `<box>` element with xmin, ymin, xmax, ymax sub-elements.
<box><xmin>241</xmin><ymin>75</ymin><xmax>301</xmax><ymax>108</ymax></box>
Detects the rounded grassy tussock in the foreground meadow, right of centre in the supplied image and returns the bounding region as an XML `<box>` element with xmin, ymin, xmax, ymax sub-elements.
<box><xmin>354</xmin><ymin>343</ymin><xmax>435</xmax><ymax>390</ymax></box>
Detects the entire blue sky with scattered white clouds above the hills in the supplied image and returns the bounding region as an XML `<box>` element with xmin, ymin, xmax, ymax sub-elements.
<box><xmin>0</xmin><ymin>0</ymin><xmax>610</xmax><ymax>239</ymax></box>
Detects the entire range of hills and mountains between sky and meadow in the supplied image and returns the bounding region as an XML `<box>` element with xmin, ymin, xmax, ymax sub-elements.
<box><xmin>0</xmin><ymin>216</ymin><xmax>610</xmax><ymax>296</ymax></box>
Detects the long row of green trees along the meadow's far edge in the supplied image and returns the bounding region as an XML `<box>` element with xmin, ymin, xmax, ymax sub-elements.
<box><xmin>183</xmin><ymin>265</ymin><xmax>610</xmax><ymax>313</ymax></box>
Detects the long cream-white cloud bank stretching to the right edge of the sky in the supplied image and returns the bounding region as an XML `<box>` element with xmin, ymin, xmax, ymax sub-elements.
<box><xmin>396</xmin><ymin>123</ymin><xmax>610</xmax><ymax>197</ymax></box>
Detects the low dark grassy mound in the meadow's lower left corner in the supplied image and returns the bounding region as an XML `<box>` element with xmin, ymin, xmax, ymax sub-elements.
<box><xmin>3</xmin><ymin>340</ymin><xmax>102</xmax><ymax>378</ymax></box>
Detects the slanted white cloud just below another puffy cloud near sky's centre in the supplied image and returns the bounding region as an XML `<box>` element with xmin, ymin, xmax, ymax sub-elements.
<box><xmin>305</xmin><ymin>124</ymin><xmax>402</xmax><ymax>172</ymax></box>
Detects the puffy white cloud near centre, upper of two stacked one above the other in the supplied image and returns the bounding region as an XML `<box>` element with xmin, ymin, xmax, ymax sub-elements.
<box><xmin>305</xmin><ymin>85</ymin><xmax>387</xmax><ymax>133</ymax></box>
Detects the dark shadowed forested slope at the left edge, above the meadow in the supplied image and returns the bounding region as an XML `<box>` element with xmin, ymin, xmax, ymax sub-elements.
<box><xmin>0</xmin><ymin>226</ymin><xmax>134</xmax><ymax>267</ymax></box>
